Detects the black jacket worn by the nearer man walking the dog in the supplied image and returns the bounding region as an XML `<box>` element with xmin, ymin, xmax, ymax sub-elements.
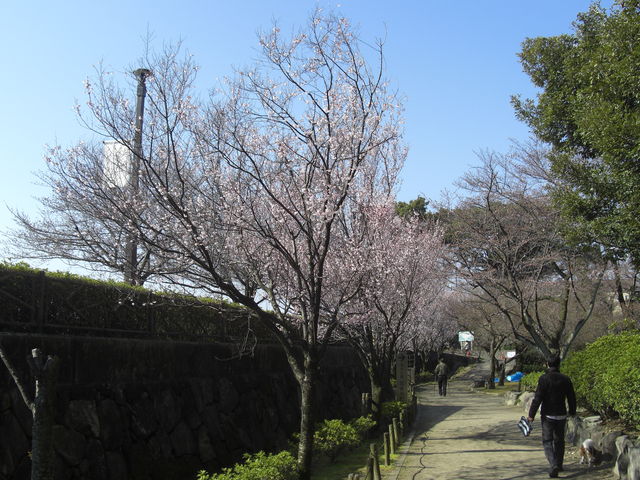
<box><xmin>529</xmin><ymin>368</ymin><xmax>576</xmax><ymax>418</ymax></box>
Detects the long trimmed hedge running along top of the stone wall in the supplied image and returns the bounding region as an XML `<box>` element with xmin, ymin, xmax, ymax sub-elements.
<box><xmin>0</xmin><ymin>263</ymin><xmax>272</xmax><ymax>341</ymax></box>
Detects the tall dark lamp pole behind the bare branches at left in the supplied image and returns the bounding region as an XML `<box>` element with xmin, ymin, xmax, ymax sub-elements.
<box><xmin>124</xmin><ymin>68</ymin><xmax>151</xmax><ymax>285</ymax></box>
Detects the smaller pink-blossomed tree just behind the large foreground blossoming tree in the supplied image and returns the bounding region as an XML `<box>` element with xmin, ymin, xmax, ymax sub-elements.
<box><xmin>339</xmin><ymin>205</ymin><xmax>447</xmax><ymax>413</ymax></box>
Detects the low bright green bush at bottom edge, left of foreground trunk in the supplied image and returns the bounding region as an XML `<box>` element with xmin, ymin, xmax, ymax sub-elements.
<box><xmin>197</xmin><ymin>451</ymin><xmax>298</xmax><ymax>480</ymax></box>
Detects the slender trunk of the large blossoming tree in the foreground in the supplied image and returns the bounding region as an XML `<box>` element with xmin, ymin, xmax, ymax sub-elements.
<box><xmin>298</xmin><ymin>353</ymin><xmax>316</xmax><ymax>480</ymax></box>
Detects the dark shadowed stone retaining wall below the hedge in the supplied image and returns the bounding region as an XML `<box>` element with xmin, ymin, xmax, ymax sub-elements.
<box><xmin>0</xmin><ymin>335</ymin><xmax>368</xmax><ymax>480</ymax></box>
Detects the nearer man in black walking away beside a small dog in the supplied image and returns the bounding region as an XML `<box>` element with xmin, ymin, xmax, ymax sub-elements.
<box><xmin>529</xmin><ymin>357</ymin><xmax>576</xmax><ymax>478</ymax></box>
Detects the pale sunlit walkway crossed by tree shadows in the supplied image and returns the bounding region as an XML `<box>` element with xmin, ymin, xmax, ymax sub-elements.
<box><xmin>384</xmin><ymin>364</ymin><xmax>613</xmax><ymax>480</ymax></box>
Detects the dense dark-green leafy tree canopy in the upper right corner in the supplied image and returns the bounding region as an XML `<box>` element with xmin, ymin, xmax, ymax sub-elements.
<box><xmin>512</xmin><ymin>0</ymin><xmax>640</xmax><ymax>265</ymax></box>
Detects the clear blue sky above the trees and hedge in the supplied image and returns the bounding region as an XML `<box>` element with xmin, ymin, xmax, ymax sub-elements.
<box><xmin>0</xmin><ymin>0</ymin><xmax>611</xmax><ymax>268</ymax></box>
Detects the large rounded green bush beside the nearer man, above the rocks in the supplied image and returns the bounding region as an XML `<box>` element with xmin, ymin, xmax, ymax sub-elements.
<box><xmin>562</xmin><ymin>330</ymin><xmax>640</xmax><ymax>427</ymax></box>
